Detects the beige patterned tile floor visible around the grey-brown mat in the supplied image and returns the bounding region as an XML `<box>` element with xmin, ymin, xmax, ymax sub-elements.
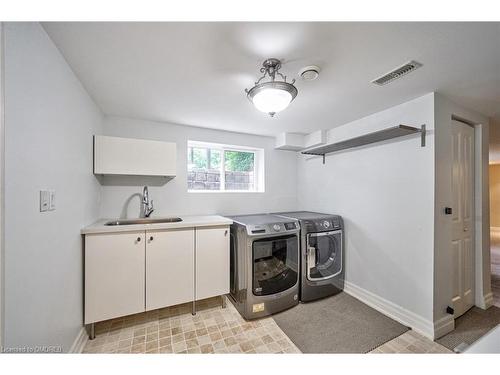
<box><xmin>83</xmin><ymin>298</ymin><xmax>451</xmax><ymax>353</ymax></box>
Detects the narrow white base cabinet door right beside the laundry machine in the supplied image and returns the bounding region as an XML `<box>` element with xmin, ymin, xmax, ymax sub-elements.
<box><xmin>196</xmin><ymin>226</ymin><xmax>229</xmax><ymax>300</ymax></box>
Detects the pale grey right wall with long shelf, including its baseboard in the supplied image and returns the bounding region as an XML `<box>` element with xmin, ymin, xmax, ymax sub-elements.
<box><xmin>297</xmin><ymin>93</ymin><xmax>434</xmax><ymax>336</ymax></box>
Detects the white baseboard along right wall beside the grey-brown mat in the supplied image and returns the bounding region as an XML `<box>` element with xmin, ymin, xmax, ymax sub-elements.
<box><xmin>344</xmin><ymin>281</ymin><xmax>435</xmax><ymax>340</ymax></box>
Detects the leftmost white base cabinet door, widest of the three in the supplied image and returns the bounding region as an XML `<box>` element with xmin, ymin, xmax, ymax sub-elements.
<box><xmin>85</xmin><ymin>232</ymin><xmax>146</xmax><ymax>324</ymax></box>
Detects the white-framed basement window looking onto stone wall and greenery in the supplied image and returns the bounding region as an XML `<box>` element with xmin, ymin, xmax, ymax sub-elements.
<box><xmin>187</xmin><ymin>141</ymin><xmax>264</xmax><ymax>193</ymax></box>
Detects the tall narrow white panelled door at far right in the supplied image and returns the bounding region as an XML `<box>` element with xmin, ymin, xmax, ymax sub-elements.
<box><xmin>451</xmin><ymin>121</ymin><xmax>474</xmax><ymax>318</ymax></box>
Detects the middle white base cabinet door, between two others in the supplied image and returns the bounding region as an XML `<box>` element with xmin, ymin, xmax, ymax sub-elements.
<box><xmin>146</xmin><ymin>229</ymin><xmax>194</xmax><ymax>310</ymax></box>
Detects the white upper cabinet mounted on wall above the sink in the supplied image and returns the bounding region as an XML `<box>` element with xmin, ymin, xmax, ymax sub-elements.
<box><xmin>94</xmin><ymin>135</ymin><xmax>177</xmax><ymax>177</ymax></box>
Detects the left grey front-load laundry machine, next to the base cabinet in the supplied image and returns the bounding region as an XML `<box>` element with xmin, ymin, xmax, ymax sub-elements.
<box><xmin>229</xmin><ymin>214</ymin><xmax>300</xmax><ymax>319</ymax></box>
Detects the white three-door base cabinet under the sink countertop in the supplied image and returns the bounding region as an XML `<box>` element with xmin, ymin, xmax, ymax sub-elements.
<box><xmin>84</xmin><ymin>226</ymin><xmax>229</xmax><ymax>324</ymax></box>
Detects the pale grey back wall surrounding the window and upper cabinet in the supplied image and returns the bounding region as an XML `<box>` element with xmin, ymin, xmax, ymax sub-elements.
<box><xmin>101</xmin><ymin>117</ymin><xmax>297</xmax><ymax>218</ymax></box>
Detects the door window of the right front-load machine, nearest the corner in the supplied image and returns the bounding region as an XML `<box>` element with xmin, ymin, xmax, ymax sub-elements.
<box><xmin>306</xmin><ymin>231</ymin><xmax>342</xmax><ymax>281</ymax></box>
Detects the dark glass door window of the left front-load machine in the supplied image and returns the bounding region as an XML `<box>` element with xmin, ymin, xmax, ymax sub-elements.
<box><xmin>252</xmin><ymin>235</ymin><xmax>299</xmax><ymax>296</ymax></box>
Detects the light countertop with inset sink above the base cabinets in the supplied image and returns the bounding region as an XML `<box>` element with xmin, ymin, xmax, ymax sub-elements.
<box><xmin>81</xmin><ymin>215</ymin><xmax>233</xmax><ymax>234</ymax></box>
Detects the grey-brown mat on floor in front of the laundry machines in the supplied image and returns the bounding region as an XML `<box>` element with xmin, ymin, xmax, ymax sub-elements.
<box><xmin>273</xmin><ymin>293</ymin><xmax>408</xmax><ymax>353</ymax></box>
